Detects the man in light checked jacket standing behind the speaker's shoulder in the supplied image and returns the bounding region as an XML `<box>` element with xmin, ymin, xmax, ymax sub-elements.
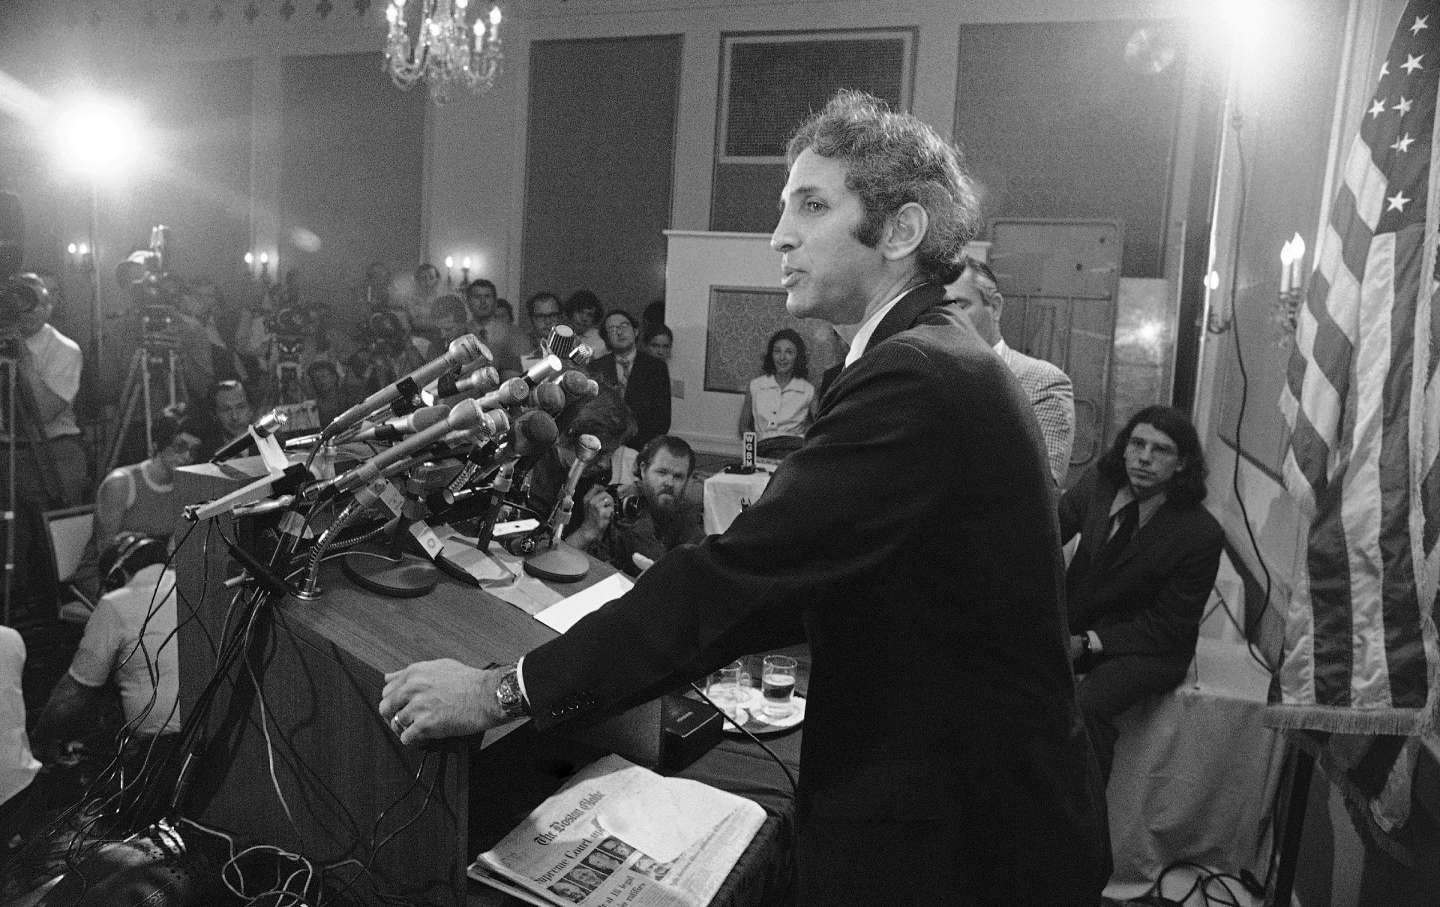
<box><xmin>945</xmin><ymin>256</ymin><xmax>1076</xmax><ymax>487</ymax></box>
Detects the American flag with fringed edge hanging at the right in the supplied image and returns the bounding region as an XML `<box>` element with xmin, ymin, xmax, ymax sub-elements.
<box><xmin>1270</xmin><ymin>0</ymin><xmax>1440</xmax><ymax>734</ymax></box>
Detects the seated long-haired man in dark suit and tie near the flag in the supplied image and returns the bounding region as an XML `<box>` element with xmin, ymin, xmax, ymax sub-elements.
<box><xmin>1060</xmin><ymin>406</ymin><xmax>1224</xmax><ymax>780</ymax></box>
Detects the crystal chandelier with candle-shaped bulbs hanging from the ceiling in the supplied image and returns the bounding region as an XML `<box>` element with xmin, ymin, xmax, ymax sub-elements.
<box><xmin>384</xmin><ymin>0</ymin><xmax>504</xmax><ymax>104</ymax></box>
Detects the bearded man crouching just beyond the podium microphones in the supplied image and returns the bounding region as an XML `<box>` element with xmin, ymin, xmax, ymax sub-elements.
<box><xmin>609</xmin><ymin>435</ymin><xmax>706</xmax><ymax>576</ymax></box>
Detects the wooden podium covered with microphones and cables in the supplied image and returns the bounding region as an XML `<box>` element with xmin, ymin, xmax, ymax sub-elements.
<box><xmin>176</xmin><ymin>458</ymin><xmax>660</xmax><ymax>904</ymax></box>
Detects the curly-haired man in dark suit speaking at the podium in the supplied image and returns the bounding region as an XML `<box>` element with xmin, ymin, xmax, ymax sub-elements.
<box><xmin>380</xmin><ymin>92</ymin><xmax>1109</xmax><ymax>907</ymax></box>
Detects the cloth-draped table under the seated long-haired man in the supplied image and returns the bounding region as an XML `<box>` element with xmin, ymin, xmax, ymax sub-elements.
<box><xmin>1104</xmin><ymin>638</ymin><xmax>1284</xmax><ymax>898</ymax></box>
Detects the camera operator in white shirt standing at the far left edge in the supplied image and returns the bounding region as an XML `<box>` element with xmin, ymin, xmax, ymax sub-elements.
<box><xmin>0</xmin><ymin>274</ymin><xmax>88</xmax><ymax>622</ymax></box>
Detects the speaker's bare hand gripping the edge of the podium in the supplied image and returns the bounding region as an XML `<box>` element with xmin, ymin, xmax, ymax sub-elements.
<box><xmin>380</xmin><ymin>658</ymin><xmax>508</xmax><ymax>744</ymax></box>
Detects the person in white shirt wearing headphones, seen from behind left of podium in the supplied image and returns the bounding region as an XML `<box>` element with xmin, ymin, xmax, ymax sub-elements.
<box><xmin>35</xmin><ymin>533</ymin><xmax>180</xmax><ymax>823</ymax></box>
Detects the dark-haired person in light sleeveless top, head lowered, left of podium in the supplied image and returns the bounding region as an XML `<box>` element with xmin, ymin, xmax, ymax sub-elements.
<box><xmin>94</xmin><ymin>407</ymin><xmax>202</xmax><ymax>549</ymax></box>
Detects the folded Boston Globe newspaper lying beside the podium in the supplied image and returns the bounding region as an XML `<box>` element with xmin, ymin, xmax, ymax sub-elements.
<box><xmin>469</xmin><ymin>756</ymin><xmax>765</xmax><ymax>907</ymax></box>
